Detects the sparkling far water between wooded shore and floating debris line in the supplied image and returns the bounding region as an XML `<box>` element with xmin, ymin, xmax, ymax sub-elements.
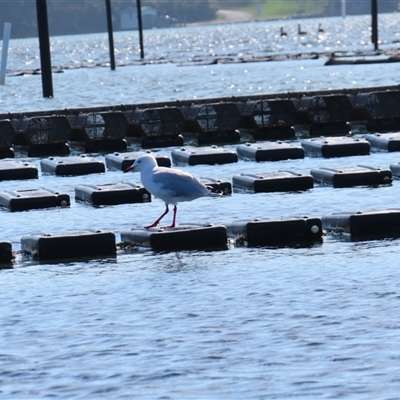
<box><xmin>8</xmin><ymin>13</ymin><xmax>400</xmax><ymax>71</ymax></box>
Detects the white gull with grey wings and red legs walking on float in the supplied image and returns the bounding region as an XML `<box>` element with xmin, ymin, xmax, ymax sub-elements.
<box><xmin>124</xmin><ymin>154</ymin><xmax>220</xmax><ymax>229</ymax></box>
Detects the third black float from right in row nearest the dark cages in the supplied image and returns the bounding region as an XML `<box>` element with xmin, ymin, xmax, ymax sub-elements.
<box><xmin>236</xmin><ymin>141</ymin><xmax>304</xmax><ymax>161</ymax></box>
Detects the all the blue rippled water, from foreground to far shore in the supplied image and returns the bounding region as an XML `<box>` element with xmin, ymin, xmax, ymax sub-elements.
<box><xmin>0</xmin><ymin>14</ymin><xmax>400</xmax><ymax>400</ymax></box>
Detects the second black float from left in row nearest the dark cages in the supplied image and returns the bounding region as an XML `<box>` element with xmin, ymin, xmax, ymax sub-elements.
<box><xmin>40</xmin><ymin>154</ymin><xmax>106</xmax><ymax>176</ymax></box>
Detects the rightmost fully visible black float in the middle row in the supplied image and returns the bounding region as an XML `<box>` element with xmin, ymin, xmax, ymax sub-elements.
<box><xmin>310</xmin><ymin>165</ymin><xmax>392</xmax><ymax>188</ymax></box>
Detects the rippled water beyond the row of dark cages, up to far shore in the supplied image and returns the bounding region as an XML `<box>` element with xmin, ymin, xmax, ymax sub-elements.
<box><xmin>0</xmin><ymin>14</ymin><xmax>400</xmax><ymax>112</ymax></box>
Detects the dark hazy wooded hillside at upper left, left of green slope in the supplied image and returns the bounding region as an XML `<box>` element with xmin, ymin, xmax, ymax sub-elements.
<box><xmin>0</xmin><ymin>0</ymin><xmax>218</xmax><ymax>38</ymax></box>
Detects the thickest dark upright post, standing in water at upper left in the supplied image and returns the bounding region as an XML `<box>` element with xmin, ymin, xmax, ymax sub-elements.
<box><xmin>36</xmin><ymin>0</ymin><xmax>53</xmax><ymax>97</ymax></box>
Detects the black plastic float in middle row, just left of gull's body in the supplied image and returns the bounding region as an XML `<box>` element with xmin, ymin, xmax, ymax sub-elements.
<box><xmin>75</xmin><ymin>182</ymin><xmax>151</xmax><ymax>206</ymax></box>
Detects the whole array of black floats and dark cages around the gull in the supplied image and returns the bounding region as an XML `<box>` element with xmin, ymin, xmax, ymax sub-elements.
<box><xmin>0</xmin><ymin>85</ymin><xmax>400</xmax><ymax>265</ymax></box>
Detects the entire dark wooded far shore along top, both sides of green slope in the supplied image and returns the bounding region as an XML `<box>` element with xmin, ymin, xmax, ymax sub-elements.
<box><xmin>0</xmin><ymin>0</ymin><xmax>400</xmax><ymax>38</ymax></box>
